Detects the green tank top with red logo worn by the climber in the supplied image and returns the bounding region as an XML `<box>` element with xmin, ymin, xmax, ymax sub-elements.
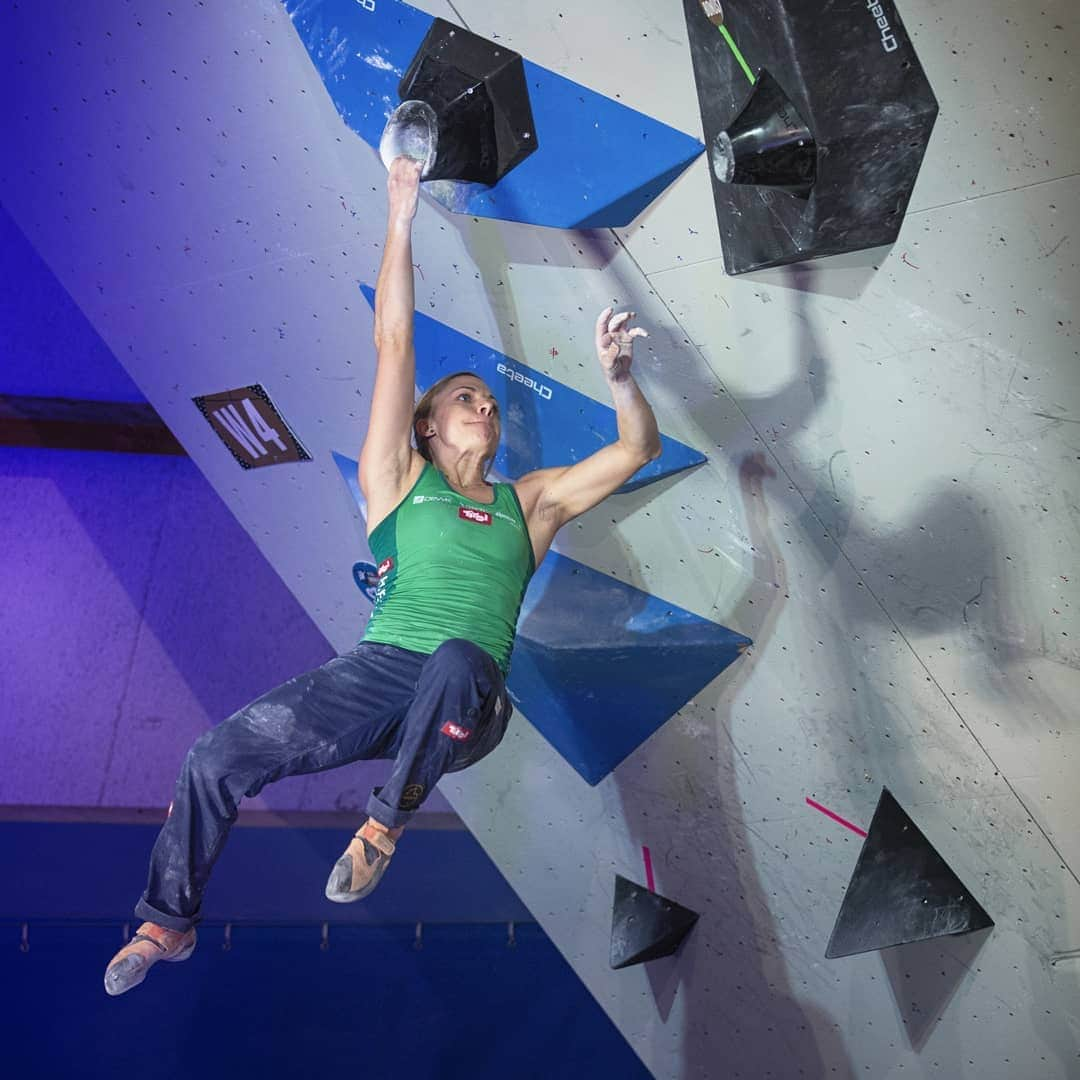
<box><xmin>363</xmin><ymin>462</ymin><xmax>536</xmax><ymax>675</ymax></box>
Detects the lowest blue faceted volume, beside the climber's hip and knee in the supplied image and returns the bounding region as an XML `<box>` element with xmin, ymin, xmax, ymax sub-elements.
<box><xmin>334</xmin><ymin>454</ymin><xmax>751</xmax><ymax>784</ymax></box>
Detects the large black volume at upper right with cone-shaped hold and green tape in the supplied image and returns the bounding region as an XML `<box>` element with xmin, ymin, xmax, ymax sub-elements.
<box><xmin>683</xmin><ymin>0</ymin><xmax>937</xmax><ymax>274</ymax></box>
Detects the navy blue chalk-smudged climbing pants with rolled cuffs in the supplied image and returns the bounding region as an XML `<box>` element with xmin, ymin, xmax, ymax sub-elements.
<box><xmin>135</xmin><ymin>640</ymin><xmax>512</xmax><ymax>931</ymax></box>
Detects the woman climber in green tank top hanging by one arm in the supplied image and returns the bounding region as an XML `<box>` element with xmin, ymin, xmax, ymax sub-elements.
<box><xmin>105</xmin><ymin>158</ymin><xmax>660</xmax><ymax>995</ymax></box>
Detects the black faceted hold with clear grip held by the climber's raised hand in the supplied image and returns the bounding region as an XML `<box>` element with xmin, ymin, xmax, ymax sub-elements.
<box><xmin>380</xmin><ymin>18</ymin><xmax>539</xmax><ymax>185</ymax></box>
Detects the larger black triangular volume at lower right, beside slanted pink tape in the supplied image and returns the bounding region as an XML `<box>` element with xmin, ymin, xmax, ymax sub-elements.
<box><xmin>825</xmin><ymin>787</ymin><xmax>994</xmax><ymax>959</ymax></box>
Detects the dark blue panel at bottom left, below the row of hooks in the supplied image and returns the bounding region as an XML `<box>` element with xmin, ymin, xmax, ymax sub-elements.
<box><xmin>0</xmin><ymin>922</ymin><xmax>649</xmax><ymax>1080</ymax></box>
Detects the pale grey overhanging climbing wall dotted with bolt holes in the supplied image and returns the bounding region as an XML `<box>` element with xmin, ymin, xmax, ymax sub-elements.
<box><xmin>0</xmin><ymin>0</ymin><xmax>1080</xmax><ymax>1078</ymax></box>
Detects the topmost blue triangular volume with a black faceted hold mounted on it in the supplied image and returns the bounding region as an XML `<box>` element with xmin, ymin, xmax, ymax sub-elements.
<box><xmin>285</xmin><ymin>0</ymin><xmax>704</xmax><ymax>229</ymax></box>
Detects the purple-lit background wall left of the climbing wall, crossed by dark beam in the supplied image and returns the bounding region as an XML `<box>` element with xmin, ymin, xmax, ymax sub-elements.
<box><xmin>0</xmin><ymin>207</ymin><xmax>448</xmax><ymax>811</ymax></box>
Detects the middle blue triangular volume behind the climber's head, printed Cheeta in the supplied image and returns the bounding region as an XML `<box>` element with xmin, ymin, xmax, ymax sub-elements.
<box><xmin>361</xmin><ymin>285</ymin><xmax>705</xmax><ymax>491</ymax></box>
